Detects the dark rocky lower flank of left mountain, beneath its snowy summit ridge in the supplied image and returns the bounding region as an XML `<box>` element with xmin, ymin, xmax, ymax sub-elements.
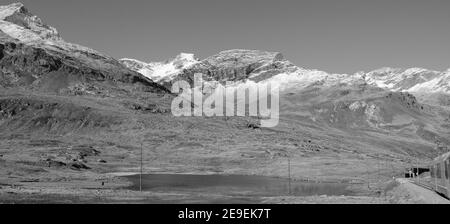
<box><xmin>0</xmin><ymin>33</ymin><xmax>166</xmax><ymax>92</ymax></box>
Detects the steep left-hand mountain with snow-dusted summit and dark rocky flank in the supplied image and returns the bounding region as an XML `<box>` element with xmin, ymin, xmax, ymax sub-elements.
<box><xmin>0</xmin><ymin>3</ymin><xmax>165</xmax><ymax>92</ymax></box>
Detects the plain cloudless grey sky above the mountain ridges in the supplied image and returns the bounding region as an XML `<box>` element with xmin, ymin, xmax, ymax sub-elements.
<box><xmin>6</xmin><ymin>0</ymin><xmax>450</xmax><ymax>73</ymax></box>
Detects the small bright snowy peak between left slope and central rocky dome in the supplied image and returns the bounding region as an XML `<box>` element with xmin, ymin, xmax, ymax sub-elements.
<box><xmin>119</xmin><ymin>53</ymin><xmax>199</xmax><ymax>82</ymax></box>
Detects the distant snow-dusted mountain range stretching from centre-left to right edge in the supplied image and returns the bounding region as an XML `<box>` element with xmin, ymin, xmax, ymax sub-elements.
<box><xmin>120</xmin><ymin>49</ymin><xmax>450</xmax><ymax>94</ymax></box>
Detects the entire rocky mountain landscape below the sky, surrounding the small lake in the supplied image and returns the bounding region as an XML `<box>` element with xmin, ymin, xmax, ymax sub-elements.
<box><xmin>0</xmin><ymin>3</ymin><xmax>450</xmax><ymax>203</ymax></box>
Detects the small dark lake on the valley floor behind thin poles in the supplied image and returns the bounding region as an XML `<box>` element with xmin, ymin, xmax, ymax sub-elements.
<box><xmin>126</xmin><ymin>174</ymin><xmax>352</xmax><ymax>196</ymax></box>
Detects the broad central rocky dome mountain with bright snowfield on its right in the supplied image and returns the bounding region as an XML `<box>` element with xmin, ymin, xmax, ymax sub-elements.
<box><xmin>157</xmin><ymin>49</ymin><xmax>370</xmax><ymax>93</ymax></box>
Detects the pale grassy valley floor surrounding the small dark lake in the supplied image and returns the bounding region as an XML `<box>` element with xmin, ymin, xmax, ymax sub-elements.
<box><xmin>0</xmin><ymin>92</ymin><xmax>444</xmax><ymax>204</ymax></box>
